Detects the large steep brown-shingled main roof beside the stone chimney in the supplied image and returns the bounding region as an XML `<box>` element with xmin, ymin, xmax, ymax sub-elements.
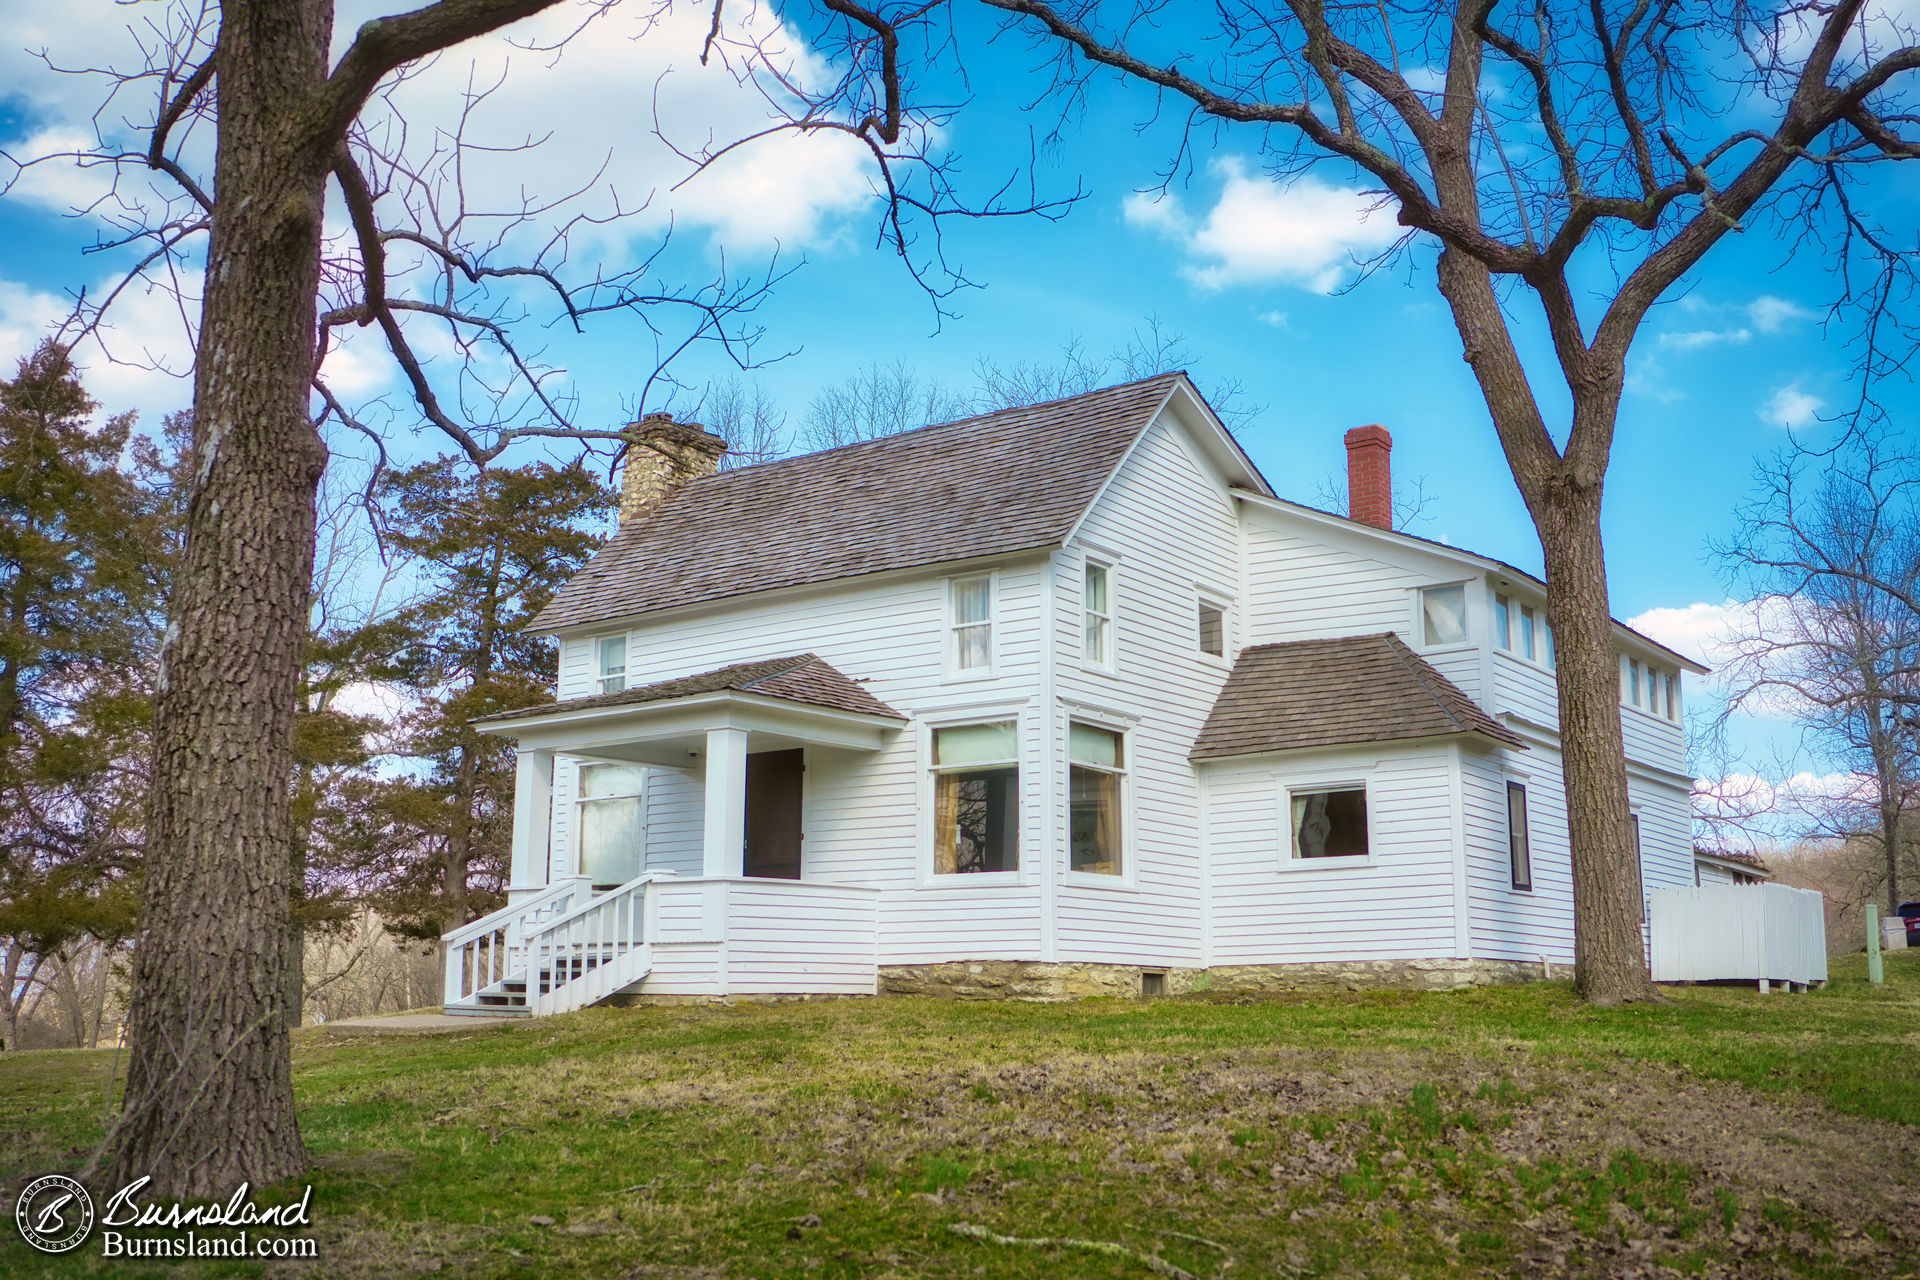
<box><xmin>528</xmin><ymin>372</ymin><xmax>1265</xmax><ymax>631</ymax></box>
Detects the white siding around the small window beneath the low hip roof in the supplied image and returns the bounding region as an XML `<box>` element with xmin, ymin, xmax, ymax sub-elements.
<box><xmin>1206</xmin><ymin>750</ymin><xmax>1457</xmax><ymax>965</ymax></box>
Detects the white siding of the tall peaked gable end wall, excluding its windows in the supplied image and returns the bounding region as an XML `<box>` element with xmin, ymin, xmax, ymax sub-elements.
<box><xmin>1048</xmin><ymin>418</ymin><xmax>1246</xmax><ymax>965</ymax></box>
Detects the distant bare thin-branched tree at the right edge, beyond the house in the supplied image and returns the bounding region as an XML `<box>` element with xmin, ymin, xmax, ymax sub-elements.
<box><xmin>1720</xmin><ymin>426</ymin><xmax>1920</xmax><ymax>910</ymax></box>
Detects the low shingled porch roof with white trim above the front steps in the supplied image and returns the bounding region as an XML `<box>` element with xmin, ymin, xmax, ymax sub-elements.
<box><xmin>472</xmin><ymin>652</ymin><xmax>906</xmax><ymax>768</ymax></box>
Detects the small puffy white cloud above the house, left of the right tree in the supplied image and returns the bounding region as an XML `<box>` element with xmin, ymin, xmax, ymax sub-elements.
<box><xmin>1123</xmin><ymin>155</ymin><xmax>1402</xmax><ymax>294</ymax></box>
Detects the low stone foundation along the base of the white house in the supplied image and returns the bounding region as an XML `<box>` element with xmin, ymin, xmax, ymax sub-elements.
<box><xmin>879</xmin><ymin>960</ymin><xmax>1572</xmax><ymax>1000</ymax></box>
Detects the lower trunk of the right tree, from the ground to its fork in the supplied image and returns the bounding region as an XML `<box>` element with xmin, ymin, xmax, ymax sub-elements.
<box><xmin>1534</xmin><ymin>484</ymin><xmax>1661</xmax><ymax>1004</ymax></box>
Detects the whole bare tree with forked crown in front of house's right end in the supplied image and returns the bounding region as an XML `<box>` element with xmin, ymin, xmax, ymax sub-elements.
<box><xmin>721</xmin><ymin>0</ymin><xmax>1920</xmax><ymax>1004</ymax></box>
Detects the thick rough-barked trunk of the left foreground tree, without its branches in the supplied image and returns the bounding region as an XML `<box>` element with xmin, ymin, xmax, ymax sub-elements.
<box><xmin>104</xmin><ymin>0</ymin><xmax>332</xmax><ymax>1197</ymax></box>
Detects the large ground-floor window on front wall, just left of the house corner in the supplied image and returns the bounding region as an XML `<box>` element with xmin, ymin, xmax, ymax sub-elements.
<box><xmin>933</xmin><ymin>720</ymin><xmax>1020</xmax><ymax>875</ymax></box>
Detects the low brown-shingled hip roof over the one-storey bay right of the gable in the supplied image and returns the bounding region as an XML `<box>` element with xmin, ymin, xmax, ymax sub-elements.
<box><xmin>1188</xmin><ymin>631</ymin><xmax>1524</xmax><ymax>760</ymax></box>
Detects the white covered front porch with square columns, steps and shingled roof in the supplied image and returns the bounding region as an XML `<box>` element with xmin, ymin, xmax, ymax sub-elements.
<box><xmin>445</xmin><ymin>654</ymin><xmax>906</xmax><ymax>1015</ymax></box>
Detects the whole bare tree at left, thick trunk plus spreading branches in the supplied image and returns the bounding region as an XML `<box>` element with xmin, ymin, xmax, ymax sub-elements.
<box><xmin>5</xmin><ymin>0</ymin><xmax>774</xmax><ymax>1197</ymax></box>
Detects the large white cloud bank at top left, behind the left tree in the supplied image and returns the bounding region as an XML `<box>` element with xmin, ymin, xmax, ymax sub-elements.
<box><xmin>0</xmin><ymin>0</ymin><xmax>874</xmax><ymax>265</ymax></box>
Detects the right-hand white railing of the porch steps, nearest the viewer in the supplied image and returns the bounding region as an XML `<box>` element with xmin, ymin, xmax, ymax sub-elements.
<box><xmin>524</xmin><ymin>871</ymin><xmax>674</xmax><ymax>1017</ymax></box>
